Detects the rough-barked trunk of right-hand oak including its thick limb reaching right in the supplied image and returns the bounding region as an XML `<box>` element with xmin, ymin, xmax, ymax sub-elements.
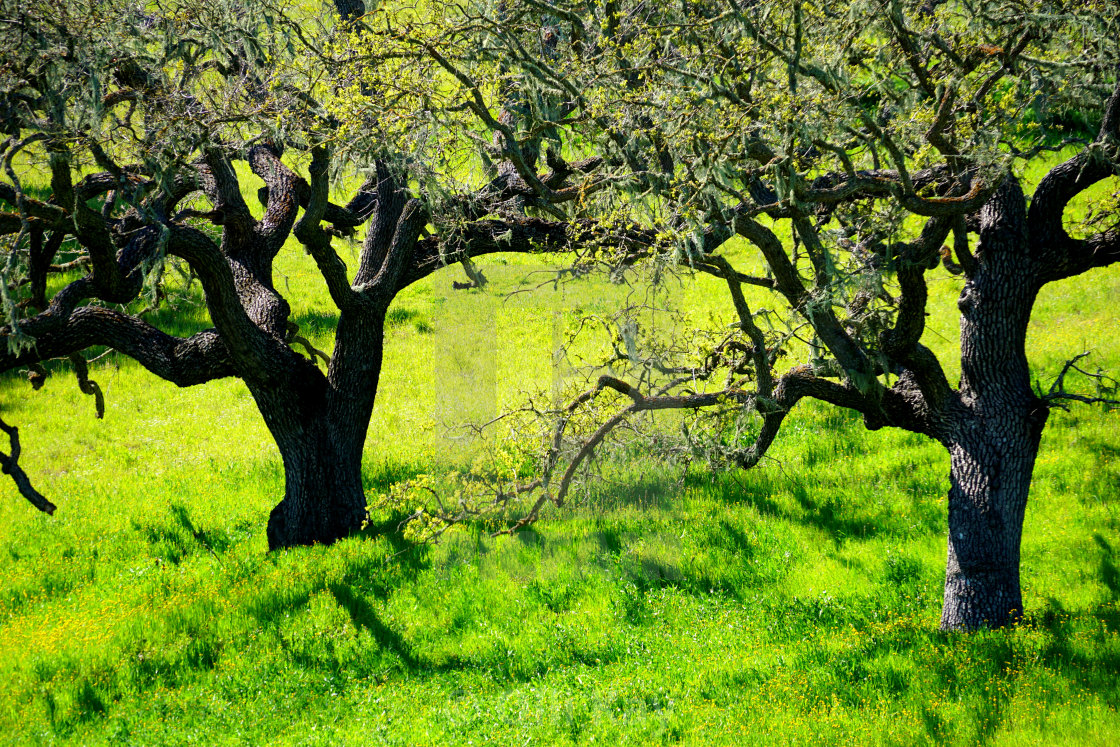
<box><xmin>941</xmin><ymin>84</ymin><xmax>1120</xmax><ymax>631</ymax></box>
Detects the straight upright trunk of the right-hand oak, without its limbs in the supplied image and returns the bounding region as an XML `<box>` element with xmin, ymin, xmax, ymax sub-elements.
<box><xmin>941</xmin><ymin>179</ymin><xmax>1048</xmax><ymax>631</ymax></box>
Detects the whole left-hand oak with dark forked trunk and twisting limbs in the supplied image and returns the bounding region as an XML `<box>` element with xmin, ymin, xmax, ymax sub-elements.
<box><xmin>0</xmin><ymin>0</ymin><xmax>622</xmax><ymax>548</ymax></box>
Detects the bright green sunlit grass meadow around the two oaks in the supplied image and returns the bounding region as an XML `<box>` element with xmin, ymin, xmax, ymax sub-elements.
<box><xmin>0</xmin><ymin>143</ymin><xmax>1120</xmax><ymax>745</ymax></box>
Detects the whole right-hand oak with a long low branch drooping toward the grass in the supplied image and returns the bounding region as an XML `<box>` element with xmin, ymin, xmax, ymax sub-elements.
<box><xmin>378</xmin><ymin>0</ymin><xmax>1120</xmax><ymax>629</ymax></box>
